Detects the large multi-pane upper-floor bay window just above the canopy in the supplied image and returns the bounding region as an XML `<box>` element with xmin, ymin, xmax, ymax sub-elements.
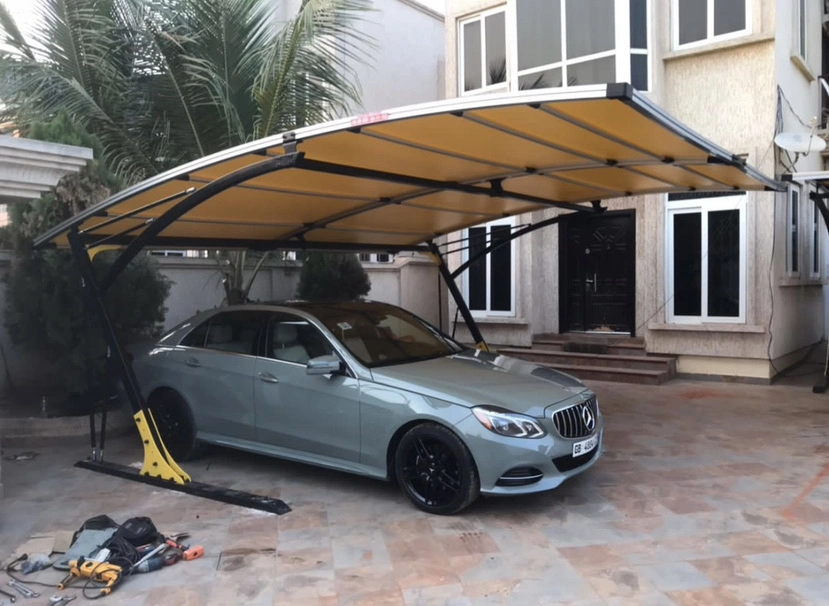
<box><xmin>458</xmin><ymin>0</ymin><xmax>651</xmax><ymax>95</ymax></box>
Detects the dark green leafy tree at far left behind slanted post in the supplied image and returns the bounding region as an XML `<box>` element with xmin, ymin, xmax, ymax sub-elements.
<box><xmin>4</xmin><ymin>114</ymin><xmax>170</xmax><ymax>406</ymax></box>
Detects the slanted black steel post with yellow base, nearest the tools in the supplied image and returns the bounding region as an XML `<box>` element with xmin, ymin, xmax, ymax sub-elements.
<box><xmin>68</xmin><ymin>228</ymin><xmax>190</xmax><ymax>484</ymax></box>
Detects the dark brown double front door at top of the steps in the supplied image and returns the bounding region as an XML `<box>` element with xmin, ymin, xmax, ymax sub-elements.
<box><xmin>559</xmin><ymin>211</ymin><xmax>636</xmax><ymax>335</ymax></box>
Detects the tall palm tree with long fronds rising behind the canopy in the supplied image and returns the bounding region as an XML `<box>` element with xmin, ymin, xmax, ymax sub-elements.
<box><xmin>0</xmin><ymin>0</ymin><xmax>373</xmax><ymax>302</ymax></box>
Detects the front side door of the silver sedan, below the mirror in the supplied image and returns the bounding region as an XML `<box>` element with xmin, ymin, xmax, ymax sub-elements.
<box><xmin>254</xmin><ymin>312</ymin><xmax>360</xmax><ymax>462</ymax></box>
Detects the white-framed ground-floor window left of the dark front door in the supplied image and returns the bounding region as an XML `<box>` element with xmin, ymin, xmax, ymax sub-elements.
<box><xmin>463</xmin><ymin>218</ymin><xmax>515</xmax><ymax>316</ymax></box>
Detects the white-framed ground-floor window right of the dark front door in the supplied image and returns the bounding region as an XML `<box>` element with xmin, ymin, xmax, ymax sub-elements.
<box><xmin>665</xmin><ymin>194</ymin><xmax>746</xmax><ymax>324</ymax></box>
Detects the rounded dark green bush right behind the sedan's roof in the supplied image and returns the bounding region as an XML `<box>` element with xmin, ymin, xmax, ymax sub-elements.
<box><xmin>297</xmin><ymin>252</ymin><xmax>371</xmax><ymax>301</ymax></box>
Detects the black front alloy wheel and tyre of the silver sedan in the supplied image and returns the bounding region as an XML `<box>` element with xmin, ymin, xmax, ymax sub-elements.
<box><xmin>395</xmin><ymin>423</ymin><xmax>480</xmax><ymax>515</ymax></box>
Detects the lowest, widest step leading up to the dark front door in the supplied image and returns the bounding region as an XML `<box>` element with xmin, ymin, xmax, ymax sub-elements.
<box><xmin>498</xmin><ymin>346</ymin><xmax>676</xmax><ymax>385</ymax></box>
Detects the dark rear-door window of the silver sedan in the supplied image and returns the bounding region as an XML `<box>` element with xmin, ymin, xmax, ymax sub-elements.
<box><xmin>182</xmin><ymin>311</ymin><xmax>264</xmax><ymax>356</ymax></box>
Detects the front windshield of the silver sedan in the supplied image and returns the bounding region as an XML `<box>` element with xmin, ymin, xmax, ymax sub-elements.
<box><xmin>300</xmin><ymin>303</ymin><xmax>464</xmax><ymax>368</ymax></box>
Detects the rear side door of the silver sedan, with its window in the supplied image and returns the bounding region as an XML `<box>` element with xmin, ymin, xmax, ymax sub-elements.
<box><xmin>170</xmin><ymin>310</ymin><xmax>267</xmax><ymax>440</ymax></box>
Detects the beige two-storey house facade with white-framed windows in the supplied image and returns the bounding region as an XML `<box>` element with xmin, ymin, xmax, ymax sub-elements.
<box><xmin>446</xmin><ymin>0</ymin><xmax>826</xmax><ymax>381</ymax></box>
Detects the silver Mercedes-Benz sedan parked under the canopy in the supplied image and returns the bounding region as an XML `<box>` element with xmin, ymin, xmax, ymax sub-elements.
<box><xmin>133</xmin><ymin>302</ymin><xmax>603</xmax><ymax>514</ymax></box>
